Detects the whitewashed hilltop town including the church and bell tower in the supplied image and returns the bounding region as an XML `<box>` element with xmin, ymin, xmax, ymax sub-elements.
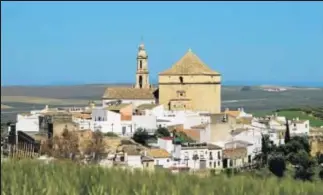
<box><xmin>2</xmin><ymin>44</ymin><xmax>323</xmax><ymax>175</ymax></box>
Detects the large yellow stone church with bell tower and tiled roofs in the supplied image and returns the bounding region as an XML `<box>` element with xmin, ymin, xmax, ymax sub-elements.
<box><xmin>102</xmin><ymin>44</ymin><xmax>221</xmax><ymax>113</ymax></box>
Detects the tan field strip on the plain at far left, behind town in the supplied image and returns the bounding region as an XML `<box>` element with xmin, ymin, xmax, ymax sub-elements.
<box><xmin>1</xmin><ymin>96</ymin><xmax>100</xmax><ymax>105</ymax></box>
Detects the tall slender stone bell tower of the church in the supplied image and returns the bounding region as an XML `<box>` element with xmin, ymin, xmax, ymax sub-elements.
<box><xmin>135</xmin><ymin>43</ymin><xmax>150</xmax><ymax>89</ymax></box>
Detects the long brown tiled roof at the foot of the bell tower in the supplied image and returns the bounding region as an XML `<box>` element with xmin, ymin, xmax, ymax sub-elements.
<box><xmin>102</xmin><ymin>87</ymin><xmax>156</xmax><ymax>99</ymax></box>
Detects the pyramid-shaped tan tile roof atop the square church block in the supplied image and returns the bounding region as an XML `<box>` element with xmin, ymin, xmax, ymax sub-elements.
<box><xmin>159</xmin><ymin>49</ymin><xmax>220</xmax><ymax>75</ymax></box>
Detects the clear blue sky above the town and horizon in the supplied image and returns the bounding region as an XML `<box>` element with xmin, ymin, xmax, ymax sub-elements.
<box><xmin>1</xmin><ymin>2</ymin><xmax>323</xmax><ymax>85</ymax></box>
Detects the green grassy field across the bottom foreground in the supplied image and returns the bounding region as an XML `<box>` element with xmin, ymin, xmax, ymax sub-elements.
<box><xmin>1</xmin><ymin>161</ymin><xmax>323</xmax><ymax>195</ymax></box>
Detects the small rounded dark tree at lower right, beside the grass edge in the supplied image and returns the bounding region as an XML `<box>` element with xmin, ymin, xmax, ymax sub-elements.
<box><xmin>268</xmin><ymin>154</ymin><xmax>286</xmax><ymax>177</ymax></box>
